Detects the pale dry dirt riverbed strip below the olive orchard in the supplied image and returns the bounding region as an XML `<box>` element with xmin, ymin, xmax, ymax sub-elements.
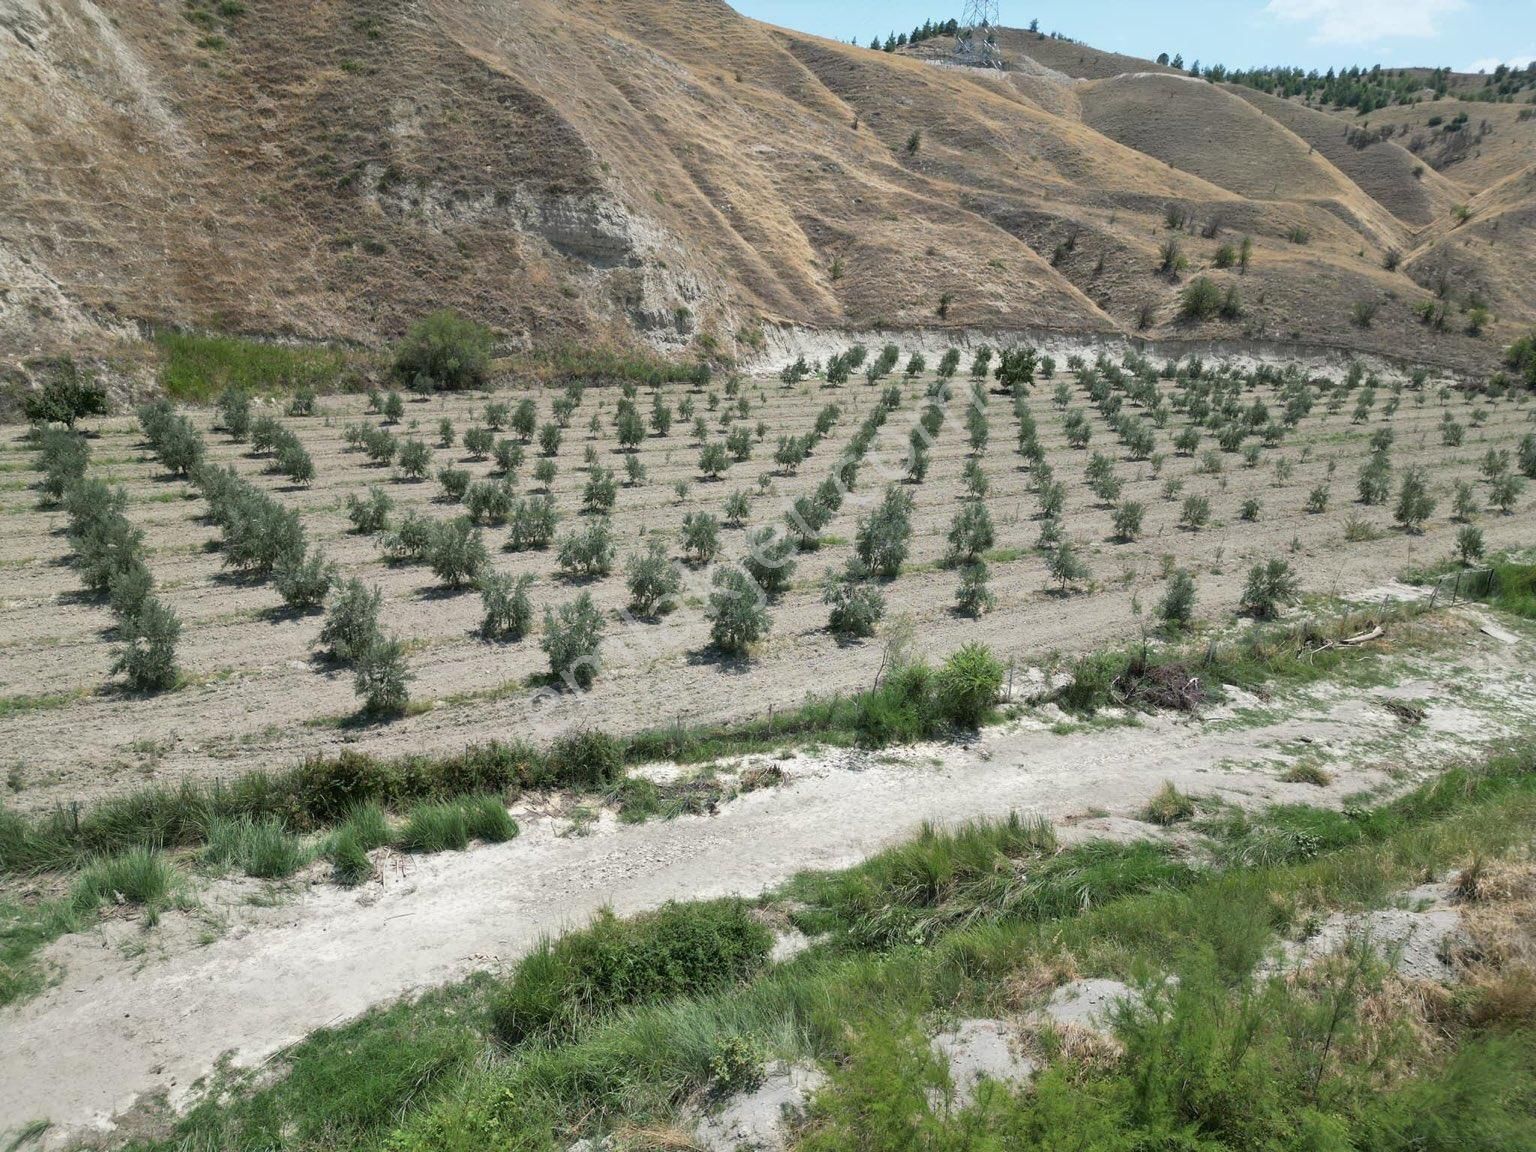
<box><xmin>0</xmin><ymin>610</ymin><xmax>1536</xmax><ymax>1130</ymax></box>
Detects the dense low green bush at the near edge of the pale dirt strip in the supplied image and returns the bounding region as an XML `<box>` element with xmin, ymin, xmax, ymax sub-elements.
<box><xmin>492</xmin><ymin>900</ymin><xmax>773</xmax><ymax>1044</ymax></box>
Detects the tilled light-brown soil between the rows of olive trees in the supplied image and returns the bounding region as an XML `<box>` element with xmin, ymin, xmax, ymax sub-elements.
<box><xmin>0</xmin><ymin>360</ymin><xmax>1536</xmax><ymax>809</ymax></box>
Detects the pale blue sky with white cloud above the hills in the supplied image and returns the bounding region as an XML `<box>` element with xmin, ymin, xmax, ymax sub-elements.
<box><xmin>730</xmin><ymin>0</ymin><xmax>1536</xmax><ymax>72</ymax></box>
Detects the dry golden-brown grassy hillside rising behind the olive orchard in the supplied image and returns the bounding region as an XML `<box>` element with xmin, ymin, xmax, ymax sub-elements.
<box><xmin>0</xmin><ymin>0</ymin><xmax>1536</xmax><ymax>379</ymax></box>
